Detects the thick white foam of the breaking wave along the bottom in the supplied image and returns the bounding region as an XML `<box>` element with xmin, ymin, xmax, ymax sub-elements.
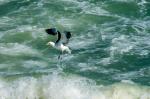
<box><xmin>0</xmin><ymin>75</ymin><xmax>150</xmax><ymax>99</ymax></box>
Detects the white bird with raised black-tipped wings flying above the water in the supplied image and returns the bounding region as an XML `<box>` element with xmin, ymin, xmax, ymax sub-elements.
<box><xmin>45</xmin><ymin>28</ymin><xmax>71</xmax><ymax>58</ymax></box>
